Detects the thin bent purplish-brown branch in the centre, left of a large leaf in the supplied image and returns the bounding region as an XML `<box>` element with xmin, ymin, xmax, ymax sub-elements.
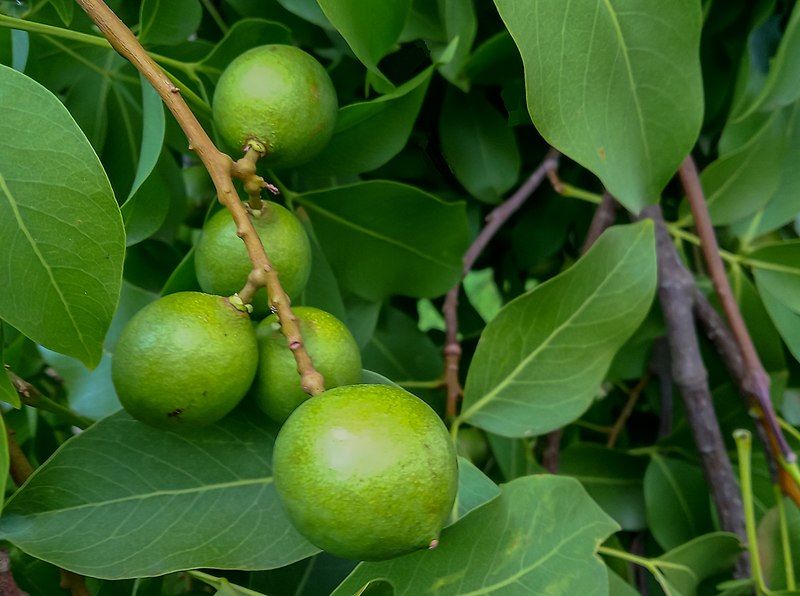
<box><xmin>442</xmin><ymin>149</ymin><xmax>560</xmax><ymax>418</ymax></box>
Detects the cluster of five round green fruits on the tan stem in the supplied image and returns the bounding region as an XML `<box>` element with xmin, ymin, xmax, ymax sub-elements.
<box><xmin>112</xmin><ymin>45</ymin><xmax>457</xmax><ymax>560</ymax></box>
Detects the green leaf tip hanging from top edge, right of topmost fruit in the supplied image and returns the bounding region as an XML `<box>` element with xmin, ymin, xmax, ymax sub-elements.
<box><xmin>317</xmin><ymin>0</ymin><xmax>411</xmax><ymax>74</ymax></box>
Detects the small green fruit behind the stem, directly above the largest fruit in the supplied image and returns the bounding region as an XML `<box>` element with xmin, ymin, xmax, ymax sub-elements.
<box><xmin>253</xmin><ymin>306</ymin><xmax>361</xmax><ymax>423</ymax></box>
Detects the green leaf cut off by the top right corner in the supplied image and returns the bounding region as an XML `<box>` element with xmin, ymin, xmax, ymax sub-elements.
<box><xmin>740</xmin><ymin>5</ymin><xmax>800</xmax><ymax>119</ymax></box>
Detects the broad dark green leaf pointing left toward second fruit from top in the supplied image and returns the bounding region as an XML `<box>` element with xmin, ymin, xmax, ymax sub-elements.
<box><xmin>295</xmin><ymin>180</ymin><xmax>468</xmax><ymax>300</ymax></box>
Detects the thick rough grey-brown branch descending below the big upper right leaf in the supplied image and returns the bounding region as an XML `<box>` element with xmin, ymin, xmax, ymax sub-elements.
<box><xmin>642</xmin><ymin>205</ymin><xmax>749</xmax><ymax>577</ymax></box>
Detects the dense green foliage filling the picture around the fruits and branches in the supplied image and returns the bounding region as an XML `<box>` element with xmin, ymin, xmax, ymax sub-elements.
<box><xmin>0</xmin><ymin>0</ymin><xmax>800</xmax><ymax>596</ymax></box>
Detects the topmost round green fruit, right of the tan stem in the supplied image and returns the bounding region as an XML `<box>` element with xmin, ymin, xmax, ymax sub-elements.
<box><xmin>213</xmin><ymin>44</ymin><xmax>338</xmax><ymax>168</ymax></box>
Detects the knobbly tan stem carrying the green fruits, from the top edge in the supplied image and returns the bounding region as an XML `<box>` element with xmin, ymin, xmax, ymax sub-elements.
<box><xmin>77</xmin><ymin>0</ymin><xmax>325</xmax><ymax>395</ymax></box>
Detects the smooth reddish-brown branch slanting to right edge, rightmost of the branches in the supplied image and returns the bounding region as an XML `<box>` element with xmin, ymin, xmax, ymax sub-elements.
<box><xmin>678</xmin><ymin>155</ymin><xmax>800</xmax><ymax>504</ymax></box>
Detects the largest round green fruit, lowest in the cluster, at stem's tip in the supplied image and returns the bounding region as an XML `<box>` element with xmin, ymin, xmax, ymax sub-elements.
<box><xmin>273</xmin><ymin>385</ymin><xmax>458</xmax><ymax>561</ymax></box>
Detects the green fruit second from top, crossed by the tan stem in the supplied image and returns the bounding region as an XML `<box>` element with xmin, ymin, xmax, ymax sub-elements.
<box><xmin>194</xmin><ymin>201</ymin><xmax>311</xmax><ymax>316</ymax></box>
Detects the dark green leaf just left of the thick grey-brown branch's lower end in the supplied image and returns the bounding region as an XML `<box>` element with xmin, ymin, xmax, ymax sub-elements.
<box><xmin>644</xmin><ymin>455</ymin><xmax>713</xmax><ymax>550</ymax></box>
